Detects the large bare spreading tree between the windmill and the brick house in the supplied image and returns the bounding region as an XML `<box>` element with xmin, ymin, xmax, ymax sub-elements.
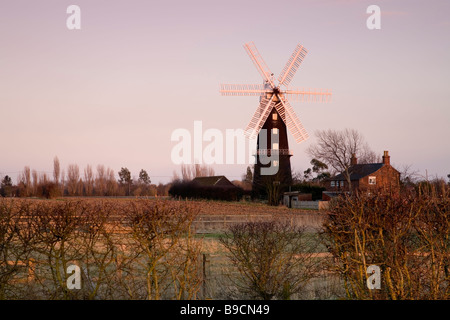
<box><xmin>306</xmin><ymin>129</ymin><xmax>376</xmax><ymax>188</ymax></box>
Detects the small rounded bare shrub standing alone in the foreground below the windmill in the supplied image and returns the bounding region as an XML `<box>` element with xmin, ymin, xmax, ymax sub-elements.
<box><xmin>220</xmin><ymin>221</ymin><xmax>316</xmax><ymax>300</ymax></box>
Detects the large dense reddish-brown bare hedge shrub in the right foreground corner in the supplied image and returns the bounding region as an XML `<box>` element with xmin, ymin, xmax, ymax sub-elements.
<box><xmin>323</xmin><ymin>187</ymin><xmax>450</xmax><ymax>299</ymax></box>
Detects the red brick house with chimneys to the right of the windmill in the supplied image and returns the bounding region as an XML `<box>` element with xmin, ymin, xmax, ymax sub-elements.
<box><xmin>323</xmin><ymin>151</ymin><xmax>400</xmax><ymax>200</ymax></box>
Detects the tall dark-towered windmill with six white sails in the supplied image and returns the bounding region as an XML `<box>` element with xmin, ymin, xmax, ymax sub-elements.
<box><xmin>220</xmin><ymin>42</ymin><xmax>331</xmax><ymax>195</ymax></box>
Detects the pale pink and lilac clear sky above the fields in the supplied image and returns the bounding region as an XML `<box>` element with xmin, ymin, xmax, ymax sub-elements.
<box><xmin>0</xmin><ymin>0</ymin><xmax>450</xmax><ymax>183</ymax></box>
